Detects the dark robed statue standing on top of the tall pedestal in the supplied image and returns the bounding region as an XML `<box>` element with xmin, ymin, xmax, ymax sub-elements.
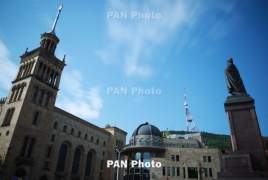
<box><xmin>224</xmin><ymin>58</ymin><xmax>247</xmax><ymax>95</ymax></box>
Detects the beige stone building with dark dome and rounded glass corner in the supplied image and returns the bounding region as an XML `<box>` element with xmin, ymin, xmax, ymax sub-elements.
<box><xmin>124</xmin><ymin>123</ymin><xmax>221</xmax><ymax>180</ymax></box>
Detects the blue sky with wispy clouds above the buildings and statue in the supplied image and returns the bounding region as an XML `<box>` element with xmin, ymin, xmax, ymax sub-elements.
<box><xmin>0</xmin><ymin>0</ymin><xmax>268</xmax><ymax>141</ymax></box>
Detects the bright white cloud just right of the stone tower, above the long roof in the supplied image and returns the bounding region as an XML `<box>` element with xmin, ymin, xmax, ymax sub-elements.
<box><xmin>56</xmin><ymin>70</ymin><xmax>103</xmax><ymax>119</ymax></box>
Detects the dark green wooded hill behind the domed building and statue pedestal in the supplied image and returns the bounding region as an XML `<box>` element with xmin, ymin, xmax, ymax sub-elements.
<box><xmin>165</xmin><ymin>131</ymin><xmax>268</xmax><ymax>151</ymax></box>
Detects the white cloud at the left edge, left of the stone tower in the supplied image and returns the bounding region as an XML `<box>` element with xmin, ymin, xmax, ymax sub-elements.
<box><xmin>0</xmin><ymin>39</ymin><xmax>17</xmax><ymax>90</ymax></box>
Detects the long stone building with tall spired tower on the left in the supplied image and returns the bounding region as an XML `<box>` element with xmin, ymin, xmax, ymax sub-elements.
<box><xmin>0</xmin><ymin>9</ymin><xmax>127</xmax><ymax>180</ymax></box>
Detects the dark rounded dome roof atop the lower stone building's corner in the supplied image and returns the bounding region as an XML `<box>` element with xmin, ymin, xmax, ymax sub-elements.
<box><xmin>132</xmin><ymin>122</ymin><xmax>162</xmax><ymax>137</ymax></box>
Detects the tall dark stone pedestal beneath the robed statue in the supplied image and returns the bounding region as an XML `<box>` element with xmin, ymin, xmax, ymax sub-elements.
<box><xmin>218</xmin><ymin>94</ymin><xmax>268</xmax><ymax>180</ymax></box>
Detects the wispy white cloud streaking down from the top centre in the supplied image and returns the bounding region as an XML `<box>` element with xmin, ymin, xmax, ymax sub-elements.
<box><xmin>96</xmin><ymin>0</ymin><xmax>189</xmax><ymax>78</ymax></box>
